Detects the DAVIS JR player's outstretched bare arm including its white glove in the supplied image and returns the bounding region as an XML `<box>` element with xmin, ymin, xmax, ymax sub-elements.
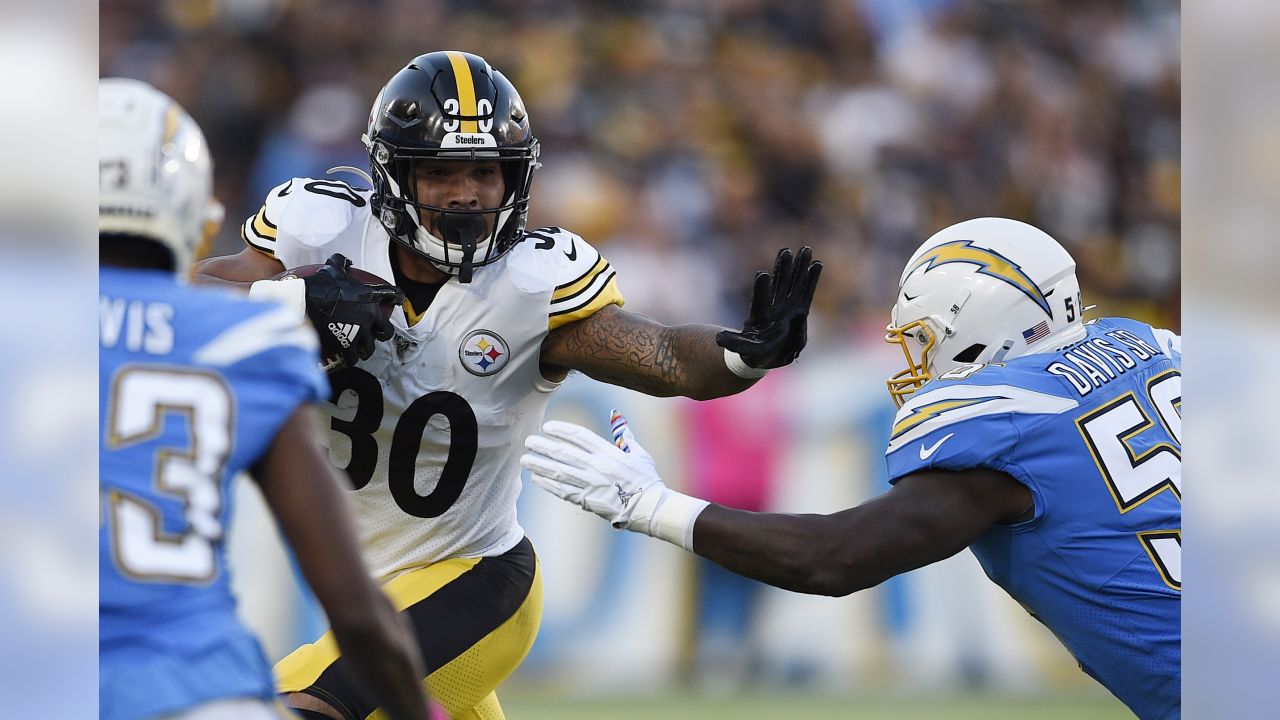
<box><xmin>520</xmin><ymin>420</ymin><xmax>1032</xmax><ymax>596</ymax></box>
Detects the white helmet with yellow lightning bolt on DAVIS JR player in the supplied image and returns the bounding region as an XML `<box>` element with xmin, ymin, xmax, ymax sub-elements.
<box><xmin>884</xmin><ymin>218</ymin><xmax>1084</xmax><ymax>406</ymax></box>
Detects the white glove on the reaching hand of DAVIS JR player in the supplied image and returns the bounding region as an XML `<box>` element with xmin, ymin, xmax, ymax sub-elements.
<box><xmin>520</xmin><ymin>411</ymin><xmax>709</xmax><ymax>550</ymax></box>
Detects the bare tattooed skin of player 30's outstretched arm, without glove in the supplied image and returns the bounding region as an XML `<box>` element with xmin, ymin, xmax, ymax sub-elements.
<box><xmin>541</xmin><ymin>305</ymin><xmax>753</xmax><ymax>400</ymax></box>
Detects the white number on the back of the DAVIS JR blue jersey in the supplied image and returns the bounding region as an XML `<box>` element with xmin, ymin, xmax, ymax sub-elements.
<box><xmin>1075</xmin><ymin>370</ymin><xmax>1183</xmax><ymax>589</ymax></box>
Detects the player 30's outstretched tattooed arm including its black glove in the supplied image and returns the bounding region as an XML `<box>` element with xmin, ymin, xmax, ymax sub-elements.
<box><xmin>541</xmin><ymin>247</ymin><xmax>822</xmax><ymax>400</ymax></box>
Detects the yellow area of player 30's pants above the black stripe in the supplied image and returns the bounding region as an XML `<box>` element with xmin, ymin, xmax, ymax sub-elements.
<box><xmin>275</xmin><ymin>557</ymin><xmax>483</xmax><ymax>693</ymax></box>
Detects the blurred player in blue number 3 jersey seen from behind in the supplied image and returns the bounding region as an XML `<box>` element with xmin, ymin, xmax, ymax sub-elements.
<box><xmin>99</xmin><ymin>78</ymin><xmax>429</xmax><ymax>720</ymax></box>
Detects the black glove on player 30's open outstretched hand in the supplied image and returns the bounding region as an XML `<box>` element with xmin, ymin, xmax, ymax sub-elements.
<box><xmin>716</xmin><ymin>247</ymin><xmax>822</xmax><ymax>369</ymax></box>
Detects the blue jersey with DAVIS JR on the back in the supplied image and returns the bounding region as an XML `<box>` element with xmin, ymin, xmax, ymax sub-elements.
<box><xmin>886</xmin><ymin>318</ymin><xmax>1183</xmax><ymax>720</ymax></box>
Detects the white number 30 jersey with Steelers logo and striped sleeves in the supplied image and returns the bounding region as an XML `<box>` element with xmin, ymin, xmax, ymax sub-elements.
<box><xmin>242</xmin><ymin>178</ymin><xmax>623</xmax><ymax>578</ymax></box>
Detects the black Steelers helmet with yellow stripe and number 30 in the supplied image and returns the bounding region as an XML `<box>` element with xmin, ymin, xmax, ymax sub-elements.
<box><xmin>362</xmin><ymin>50</ymin><xmax>539</xmax><ymax>282</ymax></box>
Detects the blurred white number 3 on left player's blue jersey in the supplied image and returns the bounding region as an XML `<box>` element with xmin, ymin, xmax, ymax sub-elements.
<box><xmin>106</xmin><ymin>366</ymin><xmax>234</xmax><ymax>583</ymax></box>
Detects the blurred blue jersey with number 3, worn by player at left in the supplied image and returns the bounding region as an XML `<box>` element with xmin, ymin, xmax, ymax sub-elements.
<box><xmin>99</xmin><ymin>269</ymin><xmax>328</xmax><ymax>720</ymax></box>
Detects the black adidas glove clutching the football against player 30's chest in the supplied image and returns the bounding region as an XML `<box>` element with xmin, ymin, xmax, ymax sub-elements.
<box><xmin>302</xmin><ymin>252</ymin><xmax>404</xmax><ymax>370</ymax></box>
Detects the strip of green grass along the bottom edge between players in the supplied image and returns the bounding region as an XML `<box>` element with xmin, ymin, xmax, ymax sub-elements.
<box><xmin>502</xmin><ymin>693</ymin><xmax>1133</xmax><ymax>720</ymax></box>
